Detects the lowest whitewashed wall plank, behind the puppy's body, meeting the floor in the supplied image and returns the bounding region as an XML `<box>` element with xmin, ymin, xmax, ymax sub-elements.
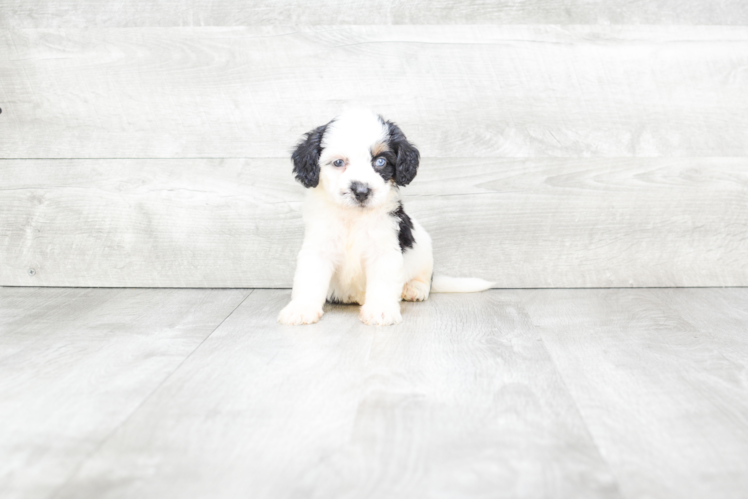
<box><xmin>0</xmin><ymin>158</ymin><xmax>748</xmax><ymax>288</ymax></box>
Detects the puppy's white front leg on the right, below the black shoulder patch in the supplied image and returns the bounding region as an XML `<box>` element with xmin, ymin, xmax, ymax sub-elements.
<box><xmin>359</xmin><ymin>251</ymin><xmax>403</xmax><ymax>326</ymax></box>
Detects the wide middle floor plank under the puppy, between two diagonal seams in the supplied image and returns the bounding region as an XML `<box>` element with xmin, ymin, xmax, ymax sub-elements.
<box><xmin>51</xmin><ymin>290</ymin><xmax>619</xmax><ymax>498</ymax></box>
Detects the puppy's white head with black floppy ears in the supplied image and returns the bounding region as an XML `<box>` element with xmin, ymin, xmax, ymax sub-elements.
<box><xmin>291</xmin><ymin>110</ymin><xmax>420</xmax><ymax>208</ymax></box>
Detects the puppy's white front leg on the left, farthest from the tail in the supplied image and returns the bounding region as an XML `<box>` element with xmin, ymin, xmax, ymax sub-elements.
<box><xmin>278</xmin><ymin>249</ymin><xmax>333</xmax><ymax>325</ymax></box>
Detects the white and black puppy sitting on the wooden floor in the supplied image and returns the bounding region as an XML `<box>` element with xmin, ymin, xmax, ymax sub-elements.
<box><xmin>278</xmin><ymin>110</ymin><xmax>492</xmax><ymax>325</ymax></box>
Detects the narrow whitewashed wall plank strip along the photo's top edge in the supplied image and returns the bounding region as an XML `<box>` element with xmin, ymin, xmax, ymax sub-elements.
<box><xmin>0</xmin><ymin>0</ymin><xmax>748</xmax><ymax>29</ymax></box>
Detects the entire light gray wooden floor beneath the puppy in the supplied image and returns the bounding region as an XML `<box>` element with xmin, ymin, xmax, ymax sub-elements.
<box><xmin>0</xmin><ymin>288</ymin><xmax>748</xmax><ymax>498</ymax></box>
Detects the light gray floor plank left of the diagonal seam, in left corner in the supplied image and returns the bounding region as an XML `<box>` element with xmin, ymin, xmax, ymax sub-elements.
<box><xmin>0</xmin><ymin>288</ymin><xmax>250</xmax><ymax>498</ymax></box>
